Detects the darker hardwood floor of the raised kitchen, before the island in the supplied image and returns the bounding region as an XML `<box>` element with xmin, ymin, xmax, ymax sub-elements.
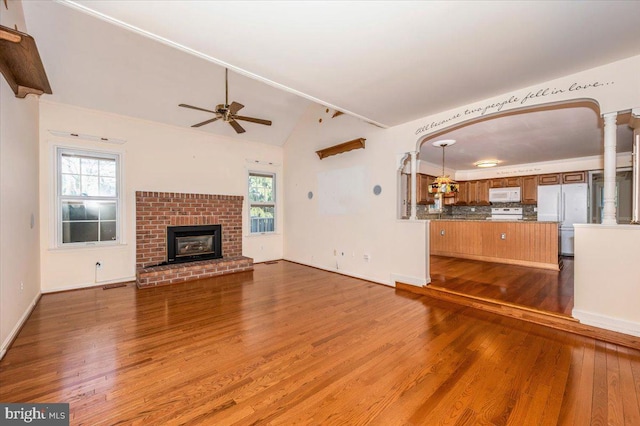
<box><xmin>430</xmin><ymin>255</ymin><xmax>574</xmax><ymax>317</ymax></box>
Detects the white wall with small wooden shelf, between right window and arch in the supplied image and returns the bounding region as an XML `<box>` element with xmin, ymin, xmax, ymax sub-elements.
<box><xmin>284</xmin><ymin>105</ymin><xmax>428</xmax><ymax>285</ymax></box>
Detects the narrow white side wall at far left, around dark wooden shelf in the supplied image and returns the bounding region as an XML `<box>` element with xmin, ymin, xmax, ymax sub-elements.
<box><xmin>0</xmin><ymin>1</ymin><xmax>40</xmax><ymax>358</ymax></box>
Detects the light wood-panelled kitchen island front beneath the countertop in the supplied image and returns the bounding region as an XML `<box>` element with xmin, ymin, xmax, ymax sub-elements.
<box><xmin>429</xmin><ymin>219</ymin><xmax>560</xmax><ymax>271</ymax></box>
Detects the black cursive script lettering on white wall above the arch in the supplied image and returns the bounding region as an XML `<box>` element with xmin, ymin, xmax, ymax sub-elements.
<box><xmin>415</xmin><ymin>81</ymin><xmax>614</xmax><ymax>135</ymax></box>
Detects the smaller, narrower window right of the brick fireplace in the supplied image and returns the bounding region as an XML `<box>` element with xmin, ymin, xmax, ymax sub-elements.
<box><xmin>249</xmin><ymin>172</ymin><xmax>276</xmax><ymax>234</ymax></box>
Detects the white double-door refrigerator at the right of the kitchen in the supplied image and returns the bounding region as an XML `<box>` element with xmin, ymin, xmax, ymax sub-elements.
<box><xmin>538</xmin><ymin>183</ymin><xmax>589</xmax><ymax>256</ymax></box>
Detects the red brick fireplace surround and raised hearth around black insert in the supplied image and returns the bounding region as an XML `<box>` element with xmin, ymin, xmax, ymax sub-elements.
<box><xmin>136</xmin><ymin>191</ymin><xmax>253</xmax><ymax>288</ymax></box>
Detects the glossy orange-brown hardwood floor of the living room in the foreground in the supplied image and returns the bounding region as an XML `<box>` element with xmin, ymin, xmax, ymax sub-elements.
<box><xmin>0</xmin><ymin>261</ymin><xmax>640</xmax><ymax>426</ymax></box>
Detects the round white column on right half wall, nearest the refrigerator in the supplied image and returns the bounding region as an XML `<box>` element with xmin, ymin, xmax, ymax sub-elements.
<box><xmin>602</xmin><ymin>112</ymin><xmax>618</xmax><ymax>225</ymax></box>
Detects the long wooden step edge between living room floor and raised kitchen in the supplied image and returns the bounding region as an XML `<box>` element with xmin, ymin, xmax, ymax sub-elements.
<box><xmin>396</xmin><ymin>282</ymin><xmax>640</xmax><ymax>350</ymax></box>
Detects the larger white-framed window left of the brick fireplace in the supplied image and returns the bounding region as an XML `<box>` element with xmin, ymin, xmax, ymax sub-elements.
<box><xmin>57</xmin><ymin>148</ymin><xmax>120</xmax><ymax>246</ymax></box>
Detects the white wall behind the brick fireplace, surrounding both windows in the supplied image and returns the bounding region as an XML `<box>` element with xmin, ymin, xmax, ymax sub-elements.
<box><xmin>40</xmin><ymin>101</ymin><xmax>284</xmax><ymax>292</ymax></box>
